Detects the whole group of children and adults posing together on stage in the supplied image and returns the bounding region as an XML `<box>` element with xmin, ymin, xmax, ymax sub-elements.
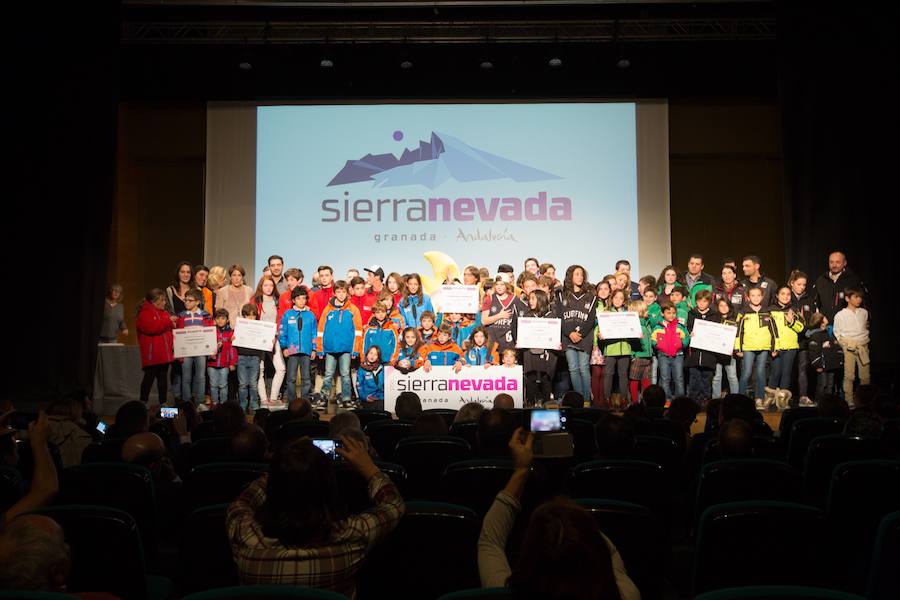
<box><xmin>116</xmin><ymin>252</ymin><xmax>870</xmax><ymax>409</ymax></box>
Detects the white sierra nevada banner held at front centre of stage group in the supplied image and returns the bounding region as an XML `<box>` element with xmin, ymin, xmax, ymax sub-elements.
<box><xmin>384</xmin><ymin>366</ymin><xmax>523</xmax><ymax>412</ymax></box>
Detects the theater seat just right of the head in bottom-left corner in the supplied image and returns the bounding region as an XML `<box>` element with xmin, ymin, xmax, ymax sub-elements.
<box><xmin>35</xmin><ymin>505</ymin><xmax>173</xmax><ymax>600</ymax></box>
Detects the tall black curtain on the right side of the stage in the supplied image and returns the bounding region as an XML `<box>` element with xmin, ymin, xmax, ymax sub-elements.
<box><xmin>778</xmin><ymin>1</ymin><xmax>900</xmax><ymax>372</ymax></box>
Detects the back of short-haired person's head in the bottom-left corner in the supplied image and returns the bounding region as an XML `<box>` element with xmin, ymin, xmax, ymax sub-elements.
<box><xmin>0</xmin><ymin>514</ymin><xmax>72</xmax><ymax>592</ymax></box>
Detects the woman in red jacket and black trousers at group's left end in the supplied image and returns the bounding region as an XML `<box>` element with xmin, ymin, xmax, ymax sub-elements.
<box><xmin>137</xmin><ymin>288</ymin><xmax>176</xmax><ymax>406</ymax></box>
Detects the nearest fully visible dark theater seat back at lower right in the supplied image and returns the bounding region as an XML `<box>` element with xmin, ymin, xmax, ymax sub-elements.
<box><xmin>693</xmin><ymin>501</ymin><xmax>831</xmax><ymax>594</ymax></box>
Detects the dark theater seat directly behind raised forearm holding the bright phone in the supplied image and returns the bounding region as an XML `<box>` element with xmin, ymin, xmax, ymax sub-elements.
<box><xmin>441</xmin><ymin>460</ymin><xmax>513</xmax><ymax>517</ymax></box>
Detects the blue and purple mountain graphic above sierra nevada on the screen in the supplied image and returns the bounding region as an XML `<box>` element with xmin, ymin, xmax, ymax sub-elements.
<box><xmin>328</xmin><ymin>132</ymin><xmax>561</xmax><ymax>189</ymax></box>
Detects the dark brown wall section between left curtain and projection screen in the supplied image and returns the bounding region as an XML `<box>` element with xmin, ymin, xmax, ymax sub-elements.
<box><xmin>108</xmin><ymin>102</ymin><xmax>206</xmax><ymax>343</ymax></box>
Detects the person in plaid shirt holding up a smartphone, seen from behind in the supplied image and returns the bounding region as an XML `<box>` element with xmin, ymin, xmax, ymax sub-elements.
<box><xmin>225</xmin><ymin>436</ymin><xmax>405</xmax><ymax>598</ymax></box>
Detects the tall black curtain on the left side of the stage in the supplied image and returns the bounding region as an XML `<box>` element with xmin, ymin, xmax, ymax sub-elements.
<box><xmin>7</xmin><ymin>0</ymin><xmax>120</xmax><ymax>406</ymax></box>
